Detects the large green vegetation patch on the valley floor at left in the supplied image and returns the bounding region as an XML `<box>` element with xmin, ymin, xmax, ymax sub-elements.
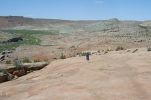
<box><xmin>0</xmin><ymin>30</ymin><xmax>59</xmax><ymax>52</ymax></box>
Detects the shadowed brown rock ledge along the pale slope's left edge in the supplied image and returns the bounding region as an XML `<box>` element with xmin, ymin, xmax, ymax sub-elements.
<box><xmin>0</xmin><ymin>62</ymin><xmax>48</xmax><ymax>83</ymax></box>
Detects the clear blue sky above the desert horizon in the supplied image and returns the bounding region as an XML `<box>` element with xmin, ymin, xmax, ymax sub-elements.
<box><xmin>0</xmin><ymin>0</ymin><xmax>151</xmax><ymax>20</ymax></box>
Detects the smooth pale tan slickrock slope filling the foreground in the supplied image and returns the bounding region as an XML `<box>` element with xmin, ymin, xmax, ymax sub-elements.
<box><xmin>0</xmin><ymin>48</ymin><xmax>151</xmax><ymax>100</ymax></box>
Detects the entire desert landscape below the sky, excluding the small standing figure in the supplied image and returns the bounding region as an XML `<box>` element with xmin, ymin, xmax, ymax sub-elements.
<box><xmin>0</xmin><ymin>16</ymin><xmax>151</xmax><ymax>100</ymax></box>
